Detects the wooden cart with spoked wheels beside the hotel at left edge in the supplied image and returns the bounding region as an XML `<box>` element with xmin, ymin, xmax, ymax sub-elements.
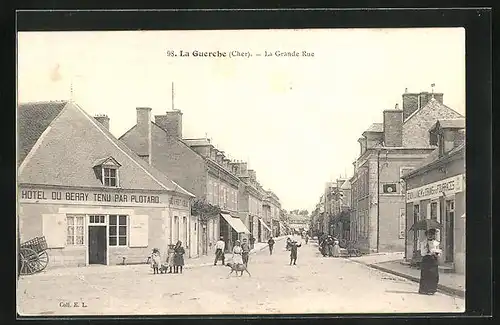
<box><xmin>19</xmin><ymin>236</ymin><xmax>49</xmax><ymax>275</ymax></box>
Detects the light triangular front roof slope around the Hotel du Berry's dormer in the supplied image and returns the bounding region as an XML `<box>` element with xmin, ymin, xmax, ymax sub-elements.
<box><xmin>19</xmin><ymin>103</ymin><xmax>192</xmax><ymax>195</ymax></box>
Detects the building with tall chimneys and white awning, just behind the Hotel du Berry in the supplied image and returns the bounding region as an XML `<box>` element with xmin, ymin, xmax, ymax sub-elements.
<box><xmin>120</xmin><ymin>108</ymin><xmax>249</xmax><ymax>255</ymax></box>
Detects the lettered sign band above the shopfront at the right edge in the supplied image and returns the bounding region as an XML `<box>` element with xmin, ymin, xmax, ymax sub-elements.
<box><xmin>406</xmin><ymin>174</ymin><xmax>465</xmax><ymax>202</ymax></box>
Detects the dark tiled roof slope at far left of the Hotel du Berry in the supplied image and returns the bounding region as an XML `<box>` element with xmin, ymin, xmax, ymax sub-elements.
<box><xmin>17</xmin><ymin>101</ymin><xmax>67</xmax><ymax>164</ymax></box>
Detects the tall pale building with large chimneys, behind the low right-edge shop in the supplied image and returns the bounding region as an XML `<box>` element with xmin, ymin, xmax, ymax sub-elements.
<box><xmin>350</xmin><ymin>91</ymin><xmax>462</xmax><ymax>252</ymax></box>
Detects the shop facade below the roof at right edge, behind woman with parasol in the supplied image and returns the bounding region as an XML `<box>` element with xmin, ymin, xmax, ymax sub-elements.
<box><xmin>405</xmin><ymin>146</ymin><xmax>465</xmax><ymax>273</ymax></box>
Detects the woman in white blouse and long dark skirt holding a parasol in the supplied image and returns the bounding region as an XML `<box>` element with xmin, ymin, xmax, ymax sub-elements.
<box><xmin>418</xmin><ymin>229</ymin><xmax>441</xmax><ymax>295</ymax></box>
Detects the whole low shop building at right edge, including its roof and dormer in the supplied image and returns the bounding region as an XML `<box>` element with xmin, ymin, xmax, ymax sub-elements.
<box><xmin>403</xmin><ymin>118</ymin><xmax>465</xmax><ymax>274</ymax></box>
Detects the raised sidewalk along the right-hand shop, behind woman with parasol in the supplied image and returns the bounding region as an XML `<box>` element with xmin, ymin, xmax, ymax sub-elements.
<box><xmin>349</xmin><ymin>253</ymin><xmax>465</xmax><ymax>298</ymax></box>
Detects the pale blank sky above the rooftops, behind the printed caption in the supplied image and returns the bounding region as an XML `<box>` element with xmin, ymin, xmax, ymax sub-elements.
<box><xmin>17</xmin><ymin>28</ymin><xmax>465</xmax><ymax>211</ymax></box>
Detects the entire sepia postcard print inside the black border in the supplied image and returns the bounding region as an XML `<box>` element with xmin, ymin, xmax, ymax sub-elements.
<box><xmin>16</xmin><ymin>28</ymin><xmax>471</xmax><ymax>317</ymax></box>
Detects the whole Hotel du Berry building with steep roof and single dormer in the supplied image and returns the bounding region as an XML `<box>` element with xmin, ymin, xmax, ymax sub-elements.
<box><xmin>17</xmin><ymin>101</ymin><xmax>194</xmax><ymax>267</ymax></box>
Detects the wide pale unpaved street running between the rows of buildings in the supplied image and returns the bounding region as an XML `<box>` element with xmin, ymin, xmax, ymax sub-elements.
<box><xmin>17</xmin><ymin>237</ymin><xmax>465</xmax><ymax>316</ymax></box>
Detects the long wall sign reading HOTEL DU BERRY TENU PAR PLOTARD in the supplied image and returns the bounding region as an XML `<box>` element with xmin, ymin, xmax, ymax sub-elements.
<box><xmin>18</xmin><ymin>189</ymin><xmax>162</xmax><ymax>204</ymax></box>
